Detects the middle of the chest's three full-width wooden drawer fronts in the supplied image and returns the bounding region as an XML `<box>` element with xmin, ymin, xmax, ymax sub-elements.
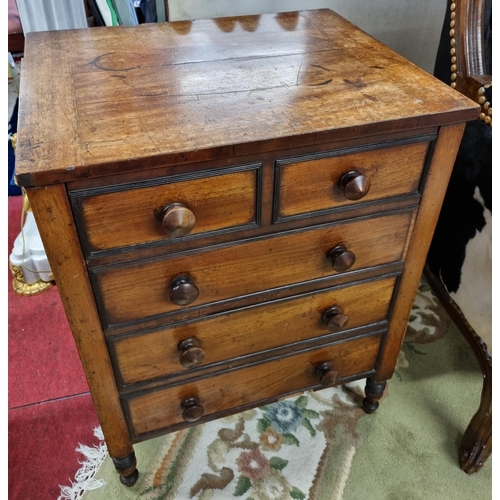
<box><xmin>110</xmin><ymin>277</ymin><xmax>396</xmax><ymax>384</ymax></box>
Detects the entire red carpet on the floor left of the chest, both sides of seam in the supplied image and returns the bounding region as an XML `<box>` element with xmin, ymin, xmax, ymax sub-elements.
<box><xmin>6</xmin><ymin>196</ymin><xmax>99</xmax><ymax>500</ymax></box>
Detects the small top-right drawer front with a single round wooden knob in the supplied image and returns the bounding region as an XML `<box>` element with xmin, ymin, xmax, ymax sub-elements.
<box><xmin>274</xmin><ymin>138</ymin><xmax>429</xmax><ymax>222</ymax></box>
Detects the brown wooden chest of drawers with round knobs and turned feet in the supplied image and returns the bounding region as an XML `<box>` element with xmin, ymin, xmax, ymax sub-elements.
<box><xmin>13</xmin><ymin>10</ymin><xmax>479</xmax><ymax>485</ymax></box>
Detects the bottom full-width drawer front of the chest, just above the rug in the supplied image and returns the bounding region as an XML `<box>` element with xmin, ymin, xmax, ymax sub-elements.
<box><xmin>123</xmin><ymin>334</ymin><xmax>381</xmax><ymax>436</ymax></box>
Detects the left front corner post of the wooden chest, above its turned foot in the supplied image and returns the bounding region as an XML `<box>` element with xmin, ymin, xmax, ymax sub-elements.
<box><xmin>27</xmin><ymin>185</ymin><xmax>133</xmax><ymax>457</ymax></box>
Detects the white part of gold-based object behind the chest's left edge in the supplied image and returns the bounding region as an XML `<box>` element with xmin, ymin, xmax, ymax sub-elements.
<box><xmin>9</xmin><ymin>212</ymin><xmax>54</xmax><ymax>285</ymax></box>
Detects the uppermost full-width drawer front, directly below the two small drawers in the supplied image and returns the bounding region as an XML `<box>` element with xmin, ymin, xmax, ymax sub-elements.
<box><xmin>91</xmin><ymin>212</ymin><xmax>413</xmax><ymax>327</ymax></box>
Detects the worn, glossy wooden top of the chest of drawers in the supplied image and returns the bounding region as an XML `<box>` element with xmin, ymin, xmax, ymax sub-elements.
<box><xmin>16</xmin><ymin>9</ymin><xmax>478</xmax><ymax>186</ymax></box>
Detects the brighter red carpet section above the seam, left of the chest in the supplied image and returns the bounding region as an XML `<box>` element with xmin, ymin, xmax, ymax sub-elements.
<box><xmin>8</xmin><ymin>196</ymin><xmax>89</xmax><ymax>408</ymax></box>
